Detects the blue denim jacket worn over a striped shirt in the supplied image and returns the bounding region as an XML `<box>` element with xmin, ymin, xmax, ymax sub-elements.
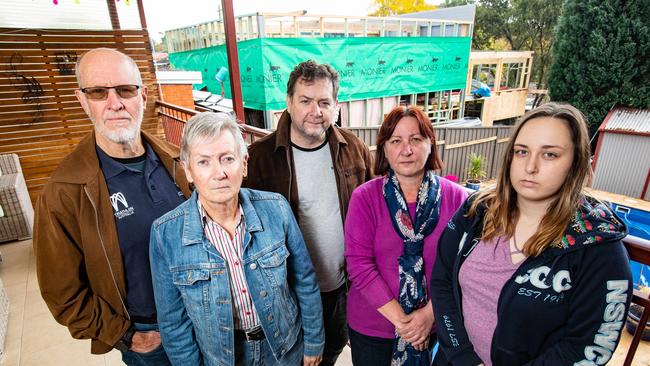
<box><xmin>150</xmin><ymin>188</ymin><xmax>325</xmax><ymax>365</ymax></box>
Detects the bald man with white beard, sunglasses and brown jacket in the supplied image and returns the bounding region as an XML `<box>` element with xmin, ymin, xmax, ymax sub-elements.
<box><xmin>34</xmin><ymin>48</ymin><xmax>190</xmax><ymax>365</ymax></box>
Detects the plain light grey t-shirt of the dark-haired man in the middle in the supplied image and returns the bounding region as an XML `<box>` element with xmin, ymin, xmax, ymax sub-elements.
<box><xmin>292</xmin><ymin>141</ymin><xmax>345</xmax><ymax>292</ymax></box>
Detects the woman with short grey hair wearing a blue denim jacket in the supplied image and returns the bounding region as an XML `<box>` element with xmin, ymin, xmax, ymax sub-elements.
<box><xmin>150</xmin><ymin>113</ymin><xmax>324</xmax><ymax>365</ymax></box>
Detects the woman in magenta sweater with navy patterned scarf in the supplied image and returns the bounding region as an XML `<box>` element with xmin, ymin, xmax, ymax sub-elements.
<box><xmin>345</xmin><ymin>107</ymin><xmax>467</xmax><ymax>366</ymax></box>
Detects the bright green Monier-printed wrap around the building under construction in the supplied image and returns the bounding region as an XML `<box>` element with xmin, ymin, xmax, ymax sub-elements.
<box><xmin>169</xmin><ymin>37</ymin><xmax>471</xmax><ymax>110</ymax></box>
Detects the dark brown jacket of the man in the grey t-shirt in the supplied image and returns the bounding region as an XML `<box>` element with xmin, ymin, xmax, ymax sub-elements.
<box><xmin>243</xmin><ymin>110</ymin><xmax>373</xmax><ymax>223</ymax></box>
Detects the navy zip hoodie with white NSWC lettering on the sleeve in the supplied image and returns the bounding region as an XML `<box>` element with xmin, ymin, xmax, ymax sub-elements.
<box><xmin>430</xmin><ymin>193</ymin><xmax>632</xmax><ymax>366</ymax></box>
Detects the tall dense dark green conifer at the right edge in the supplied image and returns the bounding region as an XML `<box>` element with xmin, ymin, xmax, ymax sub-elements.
<box><xmin>549</xmin><ymin>0</ymin><xmax>650</xmax><ymax>136</ymax></box>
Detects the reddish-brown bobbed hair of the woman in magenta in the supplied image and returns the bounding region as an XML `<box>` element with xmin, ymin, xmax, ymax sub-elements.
<box><xmin>375</xmin><ymin>106</ymin><xmax>444</xmax><ymax>175</ymax></box>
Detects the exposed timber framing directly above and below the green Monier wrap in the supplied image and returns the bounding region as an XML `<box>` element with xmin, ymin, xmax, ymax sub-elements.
<box><xmin>164</xmin><ymin>11</ymin><xmax>474</xmax><ymax>128</ymax></box>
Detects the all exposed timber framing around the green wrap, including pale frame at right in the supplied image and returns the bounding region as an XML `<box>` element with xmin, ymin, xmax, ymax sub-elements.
<box><xmin>164</xmin><ymin>12</ymin><xmax>532</xmax><ymax>128</ymax></box>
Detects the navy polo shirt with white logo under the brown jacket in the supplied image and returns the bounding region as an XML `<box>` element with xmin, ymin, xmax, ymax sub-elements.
<box><xmin>96</xmin><ymin>141</ymin><xmax>185</xmax><ymax>323</ymax></box>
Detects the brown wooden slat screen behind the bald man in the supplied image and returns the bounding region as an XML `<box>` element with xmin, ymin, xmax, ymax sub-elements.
<box><xmin>0</xmin><ymin>28</ymin><xmax>163</xmax><ymax>202</ymax></box>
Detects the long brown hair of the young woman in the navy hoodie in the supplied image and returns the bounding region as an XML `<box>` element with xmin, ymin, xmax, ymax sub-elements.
<box><xmin>468</xmin><ymin>103</ymin><xmax>591</xmax><ymax>256</ymax></box>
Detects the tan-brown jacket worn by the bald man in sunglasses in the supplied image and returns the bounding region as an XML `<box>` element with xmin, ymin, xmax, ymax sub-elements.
<box><xmin>34</xmin><ymin>132</ymin><xmax>190</xmax><ymax>354</ymax></box>
